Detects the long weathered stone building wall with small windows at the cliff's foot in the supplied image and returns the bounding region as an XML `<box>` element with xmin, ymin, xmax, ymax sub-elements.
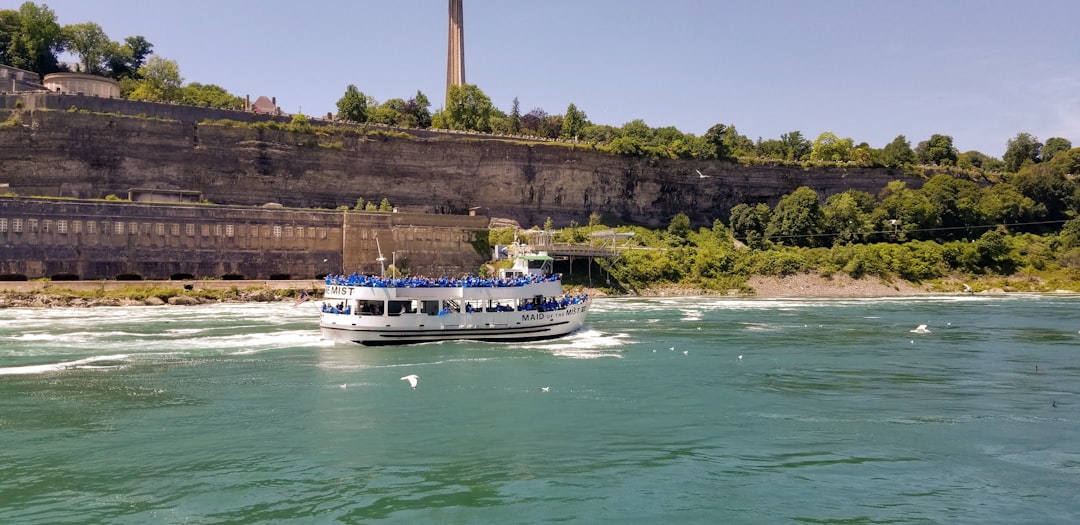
<box><xmin>0</xmin><ymin>198</ymin><xmax>487</xmax><ymax>280</ymax></box>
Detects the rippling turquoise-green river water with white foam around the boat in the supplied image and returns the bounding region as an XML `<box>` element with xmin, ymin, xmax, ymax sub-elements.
<box><xmin>0</xmin><ymin>296</ymin><xmax>1080</xmax><ymax>524</ymax></box>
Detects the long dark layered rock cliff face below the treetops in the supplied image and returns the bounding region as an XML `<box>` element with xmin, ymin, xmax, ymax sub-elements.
<box><xmin>0</xmin><ymin>104</ymin><xmax>922</xmax><ymax>227</ymax></box>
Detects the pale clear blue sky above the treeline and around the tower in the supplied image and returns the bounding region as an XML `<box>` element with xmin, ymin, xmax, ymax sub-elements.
<box><xmin>33</xmin><ymin>0</ymin><xmax>1080</xmax><ymax>158</ymax></box>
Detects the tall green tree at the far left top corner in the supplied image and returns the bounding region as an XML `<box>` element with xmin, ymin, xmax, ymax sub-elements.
<box><xmin>0</xmin><ymin>2</ymin><xmax>64</xmax><ymax>75</ymax></box>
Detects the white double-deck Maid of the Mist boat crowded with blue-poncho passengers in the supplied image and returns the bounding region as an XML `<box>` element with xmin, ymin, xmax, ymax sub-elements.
<box><xmin>319</xmin><ymin>254</ymin><xmax>590</xmax><ymax>345</ymax></box>
